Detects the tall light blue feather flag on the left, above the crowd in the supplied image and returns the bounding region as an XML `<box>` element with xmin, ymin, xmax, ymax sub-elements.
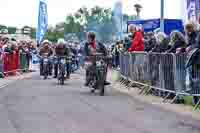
<box><xmin>36</xmin><ymin>0</ymin><xmax>48</xmax><ymax>44</ymax></box>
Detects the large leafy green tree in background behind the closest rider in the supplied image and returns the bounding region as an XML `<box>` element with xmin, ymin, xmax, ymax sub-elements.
<box><xmin>64</xmin><ymin>6</ymin><xmax>135</xmax><ymax>41</ymax></box>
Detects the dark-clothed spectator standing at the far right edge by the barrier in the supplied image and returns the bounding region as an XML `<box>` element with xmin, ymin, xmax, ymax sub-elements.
<box><xmin>185</xmin><ymin>23</ymin><xmax>200</xmax><ymax>104</ymax></box>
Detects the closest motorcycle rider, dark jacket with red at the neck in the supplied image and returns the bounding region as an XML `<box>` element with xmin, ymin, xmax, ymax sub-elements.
<box><xmin>84</xmin><ymin>32</ymin><xmax>110</xmax><ymax>86</ymax></box>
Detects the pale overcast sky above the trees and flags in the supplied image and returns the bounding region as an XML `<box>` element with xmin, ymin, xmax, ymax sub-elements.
<box><xmin>0</xmin><ymin>0</ymin><xmax>183</xmax><ymax>27</ymax></box>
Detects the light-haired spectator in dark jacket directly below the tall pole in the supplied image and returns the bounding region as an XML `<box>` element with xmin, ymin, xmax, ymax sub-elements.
<box><xmin>151</xmin><ymin>32</ymin><xmax>170</xmax><ymax>53</ymax></box>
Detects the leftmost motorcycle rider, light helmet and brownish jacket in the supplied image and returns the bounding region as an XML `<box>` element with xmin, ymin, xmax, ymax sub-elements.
<box><xmin>39</xmin><ymin>40</ymin><xmax>53</xmax><ymax>75</ymax></box>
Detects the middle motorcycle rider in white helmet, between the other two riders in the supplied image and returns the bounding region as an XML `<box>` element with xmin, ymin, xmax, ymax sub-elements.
<box><xmin>54</xmin><ymin>39</ymin><xmax>70</xmax><ymax>79</ymax></box>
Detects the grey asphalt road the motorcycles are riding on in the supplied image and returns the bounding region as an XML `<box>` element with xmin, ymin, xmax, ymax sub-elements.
<box><xmin>0</xmin><ymin>73</ymin><xmax>200</xmax><ymax>133</ymax></box>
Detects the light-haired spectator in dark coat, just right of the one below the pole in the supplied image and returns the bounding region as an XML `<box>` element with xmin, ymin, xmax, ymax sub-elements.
<box><xmin>167</xmin><ymin>31</ymin><xmax>187</xmax><ymax>53</ymax></box>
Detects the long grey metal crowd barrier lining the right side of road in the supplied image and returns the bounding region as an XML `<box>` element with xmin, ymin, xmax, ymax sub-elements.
<box><xmin>120</xmin><ymin>52</ymin><xmax>200</xmax><ymax>109</ymax></box>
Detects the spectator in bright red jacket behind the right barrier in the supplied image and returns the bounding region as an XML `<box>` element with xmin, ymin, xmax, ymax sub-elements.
<box><xmin>128</xmin><ymin>25</ymin><xmax>144</xmax><ymax>52</ymax></box>
